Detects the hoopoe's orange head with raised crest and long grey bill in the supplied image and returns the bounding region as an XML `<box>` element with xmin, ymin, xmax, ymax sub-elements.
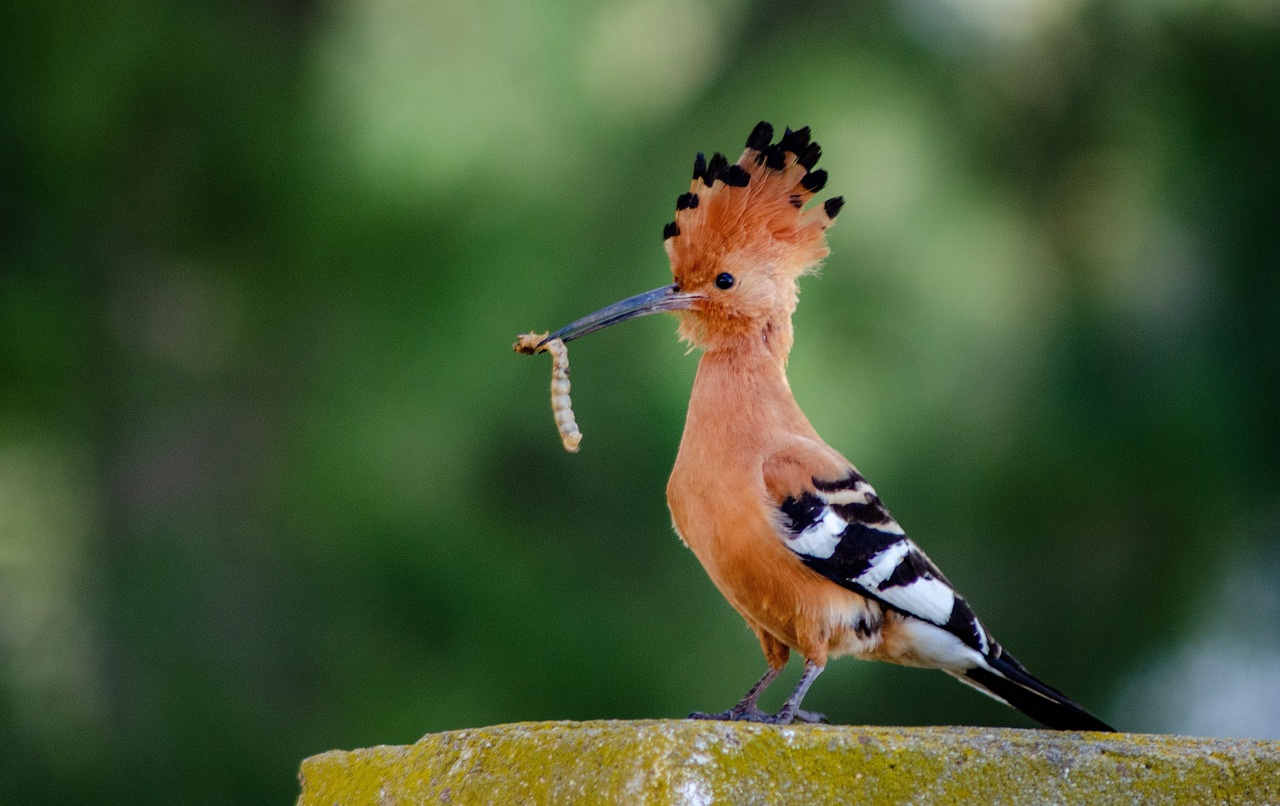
<box><xmin>548</xmin><ymin>122</ymin><xmax>844</xmax><ymax>357</ymax></box>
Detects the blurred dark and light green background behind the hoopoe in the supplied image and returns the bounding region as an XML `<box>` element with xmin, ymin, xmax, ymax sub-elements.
<box><xmin>0</xmin><ymin>0</ymin><xmax>1280</xmax><ymax>803</ymax></box>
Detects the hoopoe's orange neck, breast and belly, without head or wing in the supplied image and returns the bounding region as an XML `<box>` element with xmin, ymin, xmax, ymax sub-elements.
<box><xmin>667</xmin><ymin>342</ymin><xmax>881</xmax><ymax>664</ymax></box>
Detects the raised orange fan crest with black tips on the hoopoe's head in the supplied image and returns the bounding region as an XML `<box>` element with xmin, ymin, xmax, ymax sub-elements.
<box><xmin>663</xmin><ymin>120</ymin><xmax>844</xmax><ymax>290</ymax></box>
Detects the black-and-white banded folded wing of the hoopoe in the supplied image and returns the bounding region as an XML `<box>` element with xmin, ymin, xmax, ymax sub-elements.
<box><xmin>778</xmin><ymin>471</ymin><xmax>997</xmax><ymax>655</ymax></box>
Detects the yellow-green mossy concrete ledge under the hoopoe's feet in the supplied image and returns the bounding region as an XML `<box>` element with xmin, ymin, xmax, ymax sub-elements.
<box><xmin>298</xmin><ymin>720</ymin><xmax>1280</xmax><ymax>806</ymax></box>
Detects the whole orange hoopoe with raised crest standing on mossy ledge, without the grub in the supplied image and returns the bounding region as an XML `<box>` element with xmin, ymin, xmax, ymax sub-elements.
<box><xmin>544</xmin><ymin>122</ymin><xmax>1114</xmax><ymax>732</ymax></box>
